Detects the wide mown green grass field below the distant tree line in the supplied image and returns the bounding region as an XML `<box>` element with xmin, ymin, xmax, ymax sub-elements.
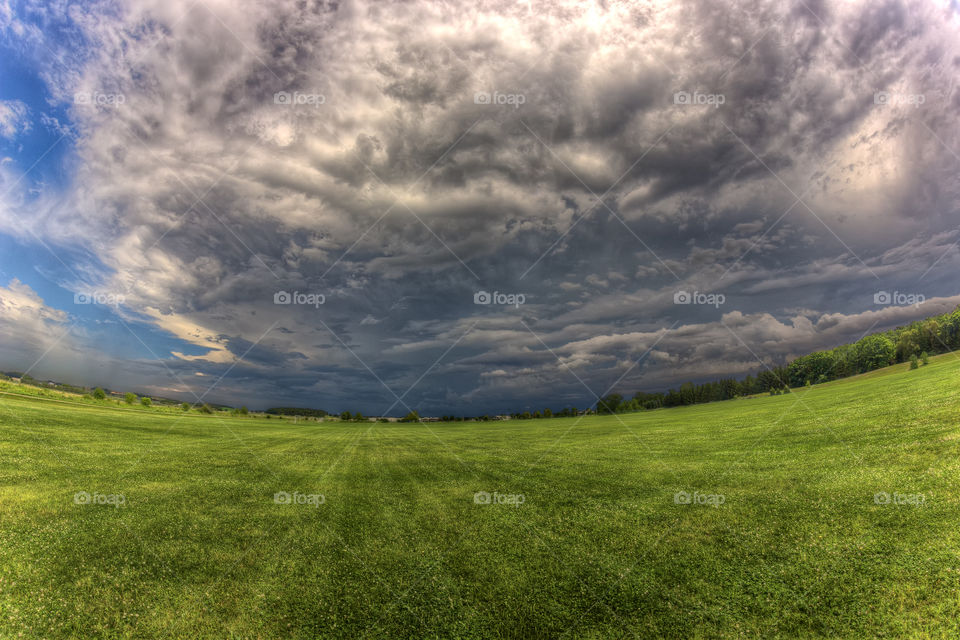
<box><xmin>0</xmin><ymin>354</ymin><xmax>960</xmax><ymax>638</ymax></box>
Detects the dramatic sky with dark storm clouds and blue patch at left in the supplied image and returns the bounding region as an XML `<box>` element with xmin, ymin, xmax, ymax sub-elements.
<box><xmin>0</xmin><ymin>0</ymin><xmax>960</xmax><ymax>415</ymax></box>
